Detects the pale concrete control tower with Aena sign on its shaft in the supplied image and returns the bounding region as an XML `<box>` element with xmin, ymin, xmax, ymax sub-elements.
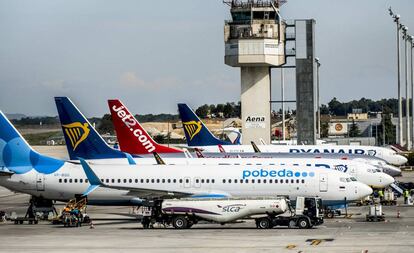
<box><xmin>224</xmin><ymin>0</ymin><xmax>286</xmax><ymax>144</ymax></box>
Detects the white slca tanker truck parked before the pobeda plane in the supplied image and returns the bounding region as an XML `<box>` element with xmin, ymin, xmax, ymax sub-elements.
<box><xmin>142</xmin><ymin>197</ymin><xmax>323</xmax><ymax>229</ymax></box>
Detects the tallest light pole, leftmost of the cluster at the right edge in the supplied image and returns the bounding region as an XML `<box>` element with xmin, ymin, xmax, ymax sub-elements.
<box><xmin>388</xmin><ymin>7</ymin><xmax>403</xmax><ymax>145</ymax></box>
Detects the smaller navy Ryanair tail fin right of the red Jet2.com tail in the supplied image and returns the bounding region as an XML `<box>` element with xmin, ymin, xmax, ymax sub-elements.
<box><xmin>178</xmin><ymin>104</ymin><xmax>232</xmax><ymax>146</ymax></box>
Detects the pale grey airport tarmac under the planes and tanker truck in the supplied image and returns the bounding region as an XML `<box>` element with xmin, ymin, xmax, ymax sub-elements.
<box><xmin>0</xmin><ymin>147</ymin><xmax>414</xmax><ymax>253</ymax></box>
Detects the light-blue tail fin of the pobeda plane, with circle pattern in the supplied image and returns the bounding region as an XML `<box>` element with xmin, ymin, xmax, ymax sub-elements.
<box><xmin>0</xmin><ymin>112</ymin><xmax>64</xmax><ymax>174</ymax></box>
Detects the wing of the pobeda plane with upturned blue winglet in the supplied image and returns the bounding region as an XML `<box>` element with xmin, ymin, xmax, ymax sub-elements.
<box><xmin>80</xmin><ymin>158</ymin><xmax>229</xmax><ymax>199</ymax></box>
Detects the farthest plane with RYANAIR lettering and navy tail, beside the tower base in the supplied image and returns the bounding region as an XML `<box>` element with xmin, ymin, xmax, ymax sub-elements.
<box><xmin>178</xmin><ymin>104</ymin><xmax>408</xmax><ymax>165</ymax></box>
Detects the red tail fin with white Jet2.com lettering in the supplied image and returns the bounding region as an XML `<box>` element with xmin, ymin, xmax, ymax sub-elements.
<box><xmin>108</xmin><ymin>99</ymin><xmax>182</xmax><ymax>154</ymax></box>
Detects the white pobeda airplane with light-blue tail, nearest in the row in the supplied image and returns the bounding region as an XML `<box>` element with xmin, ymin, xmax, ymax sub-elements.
<box><xmin>0</xmin><ymin>112</ymin><xmax>372</xmax><ymax>205</ymax></box>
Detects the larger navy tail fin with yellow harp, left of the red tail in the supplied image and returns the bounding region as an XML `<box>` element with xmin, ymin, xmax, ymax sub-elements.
<box><xmin>55</xmin><ymin>97</ymin><xmax>126</xmax><ymax>160</ymax></box>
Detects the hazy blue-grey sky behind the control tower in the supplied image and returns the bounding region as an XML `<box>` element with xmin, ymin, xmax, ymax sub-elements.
<box><xmin>0</xmin><ymin>0</ymin><xmax>414</xmax><ymax>117</ymax></box>
